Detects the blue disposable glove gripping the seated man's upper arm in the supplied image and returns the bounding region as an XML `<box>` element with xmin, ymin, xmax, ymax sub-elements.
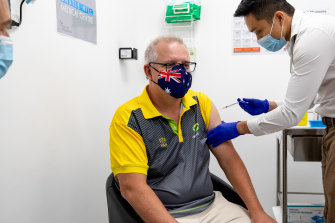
<box><xmin>207</xmin><ymin>121</ymin><xmax>240</xmax><ymax>147</ymax></box>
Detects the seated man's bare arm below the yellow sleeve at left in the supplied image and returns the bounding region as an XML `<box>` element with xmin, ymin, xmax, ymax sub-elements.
<box><xmin>123</xmin><ymin>185</ymin><xmax>177</xmax><ymax>223</ymax></box>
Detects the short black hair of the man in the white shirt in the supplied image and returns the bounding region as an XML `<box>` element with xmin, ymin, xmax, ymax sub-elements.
<box><xmin>234</xmin><ymin>0</ymin><xmax>295</xmax><ymax>24</ymax></box>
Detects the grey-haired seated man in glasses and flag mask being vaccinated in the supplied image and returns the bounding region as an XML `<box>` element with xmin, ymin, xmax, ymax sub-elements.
<box><xmin>110</xmin><ymin>37</ymin><xmax>275</xmax><ymax>223</ymax></box>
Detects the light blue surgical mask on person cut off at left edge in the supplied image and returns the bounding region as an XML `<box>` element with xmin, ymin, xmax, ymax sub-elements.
<box><xmin>0</xmin><ymin>36</ymin><xmax>13</xmax><ymax>79</ymax></box>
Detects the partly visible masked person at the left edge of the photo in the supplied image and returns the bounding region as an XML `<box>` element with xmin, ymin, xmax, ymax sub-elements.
<box><xmin>0</xmin><ymin>0</ymin><xmax>13</xmax><ymax>79</ymax></box>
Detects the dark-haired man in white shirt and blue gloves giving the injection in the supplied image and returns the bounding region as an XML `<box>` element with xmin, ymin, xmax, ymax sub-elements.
<box><xmin>207</xmin><ymin>0</ymin><xmax>335</xmax><ymax>223</ymax></box>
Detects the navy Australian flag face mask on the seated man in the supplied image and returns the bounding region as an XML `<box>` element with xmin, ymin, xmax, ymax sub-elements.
<box><xmin>152</xmin><ymin>64</ymin><xmax>192</xmax><ymax>98</ymax></box>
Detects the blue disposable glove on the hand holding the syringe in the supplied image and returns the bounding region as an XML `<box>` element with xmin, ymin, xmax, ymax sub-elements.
<box><xmin>237</xmin><ymin>98</ymin><xmax>269</xmax><ymax>115</ymax></box>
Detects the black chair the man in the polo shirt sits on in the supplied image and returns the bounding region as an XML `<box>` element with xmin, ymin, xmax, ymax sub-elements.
<box><xmin>106</xmin><ymin>173</ymin><xmax>247</xmax><ymax>223</ymax></box>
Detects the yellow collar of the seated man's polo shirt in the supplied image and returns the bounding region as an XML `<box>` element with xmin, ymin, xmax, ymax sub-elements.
<box><xmin>139</xmin><ymin>85</ymin><xmax>197</xmax><ymax>119</ymax></box>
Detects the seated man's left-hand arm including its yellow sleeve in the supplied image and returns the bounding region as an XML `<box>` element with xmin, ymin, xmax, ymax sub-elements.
<box><xmin>110</xmin><ymin>118</ymin><xmax>177</xmax><ymax>223</ymax></box>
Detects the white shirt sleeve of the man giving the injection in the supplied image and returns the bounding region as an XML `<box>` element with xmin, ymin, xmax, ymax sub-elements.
<box><xmin>247</xmin><ymin>29</ymin><xmax>335</xmax><ymax>136</ymax></box>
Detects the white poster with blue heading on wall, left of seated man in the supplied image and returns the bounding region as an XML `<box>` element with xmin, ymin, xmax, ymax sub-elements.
<box><xmin>56</xmin><ymin>0</ymin><xmax>97</xmax><ymax>44</ymax></box>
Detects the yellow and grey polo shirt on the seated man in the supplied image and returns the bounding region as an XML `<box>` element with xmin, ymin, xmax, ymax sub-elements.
<box><xmin>110</xmin><ymin>88</ymin><xmax>214</xmax><ymax>217</ymax></box>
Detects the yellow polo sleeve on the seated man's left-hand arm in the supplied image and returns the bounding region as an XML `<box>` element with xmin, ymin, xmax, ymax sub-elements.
<box><xmin>110</xmin><ymin>121</ymin><xmax>149</xmax><ymax>176</ymax></box>
